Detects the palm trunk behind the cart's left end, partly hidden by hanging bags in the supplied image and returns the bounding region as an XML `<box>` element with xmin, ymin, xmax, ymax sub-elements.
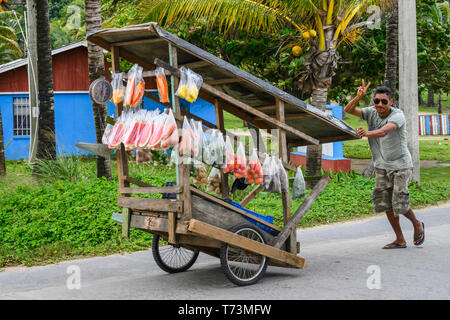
<box><xmin>85</xmin><ymin>0</ymin><xmax>111</xmax><ymax>180</ymax></box>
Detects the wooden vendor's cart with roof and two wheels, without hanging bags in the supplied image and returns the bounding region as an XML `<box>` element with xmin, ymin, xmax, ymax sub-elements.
<box><xmin>84</xmin><ymin>23</ymin><xmax>358</xmax><ymax>285</ymax></box>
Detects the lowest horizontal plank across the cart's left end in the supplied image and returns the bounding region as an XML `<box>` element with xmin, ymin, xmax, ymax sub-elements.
<box><xmin>117</xmin><ymin>197</ymin><xmax>183</xmax><ymax>212</ymax></box>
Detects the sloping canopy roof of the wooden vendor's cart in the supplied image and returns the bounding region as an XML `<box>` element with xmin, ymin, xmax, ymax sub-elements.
<box><xmin>87</xmin><ymin>22</ymin><xmax>359</xmax><ymax>147</ymax></box>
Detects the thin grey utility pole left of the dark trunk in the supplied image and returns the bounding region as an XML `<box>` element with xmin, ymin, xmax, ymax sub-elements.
<box><xmin>26</xmin><ymin>0</ymin><xmax>39</xmax><ymax>162</ymax></box>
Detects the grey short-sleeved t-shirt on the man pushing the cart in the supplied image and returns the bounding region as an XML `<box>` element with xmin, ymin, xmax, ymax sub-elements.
<box><xmin>361</xmin><ymin>106</ymin><xmax>413</xmax><ymax>170</ymax></box>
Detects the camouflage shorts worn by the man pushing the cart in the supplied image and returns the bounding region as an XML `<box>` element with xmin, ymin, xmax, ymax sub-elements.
<box><xmin>372</xmin><ymin>168</ymin><xmax>412</xmax><ymax>216</ymax></box>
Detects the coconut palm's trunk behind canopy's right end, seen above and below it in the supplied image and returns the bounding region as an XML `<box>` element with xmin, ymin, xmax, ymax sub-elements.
<box><xmin>305</xmin><ymin>89</ymin><xmax>328</xmax><ymax>188</ymax></box>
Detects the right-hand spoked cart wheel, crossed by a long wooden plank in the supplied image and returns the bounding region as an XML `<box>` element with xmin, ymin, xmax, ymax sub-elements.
<box><xmin>220</xmin><ymin>223</ymin><xmax>267</xmax><ymax>286</ymax></box>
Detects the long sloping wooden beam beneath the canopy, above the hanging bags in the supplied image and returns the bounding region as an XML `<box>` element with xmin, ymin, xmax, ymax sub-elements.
<box><xmin>154</xmin><ymin>58</ymin><xmax>319</xmax><ymax>145</ymax></box>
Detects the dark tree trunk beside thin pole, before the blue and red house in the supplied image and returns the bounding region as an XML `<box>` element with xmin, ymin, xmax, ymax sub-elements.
<box><xmin>36</xmin><ymin>0</ymin><xmax>56</xmax><ymax>159</ymax></box>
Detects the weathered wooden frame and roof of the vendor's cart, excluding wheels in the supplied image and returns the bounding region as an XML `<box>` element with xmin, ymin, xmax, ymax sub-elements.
<box><xmin>88</xmin><ymin>23</ymin><xmax>358</xmax><ymax>285</ymax></box>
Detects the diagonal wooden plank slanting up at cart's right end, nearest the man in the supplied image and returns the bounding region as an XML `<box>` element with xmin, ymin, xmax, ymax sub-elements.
<box><xmin>273</xmin><ymin>175</ymin><xmax>331</xmax><ymax>248</ymax></box>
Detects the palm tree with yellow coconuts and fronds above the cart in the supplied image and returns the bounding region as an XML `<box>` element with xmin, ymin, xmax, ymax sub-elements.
<box><xmin>136</xmin><ymin>0</ymin><xmax>390</xmax><ymax>187</ymax></box>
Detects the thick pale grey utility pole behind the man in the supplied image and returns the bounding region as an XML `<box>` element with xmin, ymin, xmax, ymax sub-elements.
<box><xmin>398</xmin><ymin>0</ymin><xmax>420</xmax><ymax>183</ymax></box>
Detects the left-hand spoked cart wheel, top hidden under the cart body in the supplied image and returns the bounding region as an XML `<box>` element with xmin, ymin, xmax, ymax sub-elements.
<box><xmin>152</xmin><ymin>234</ymin><xmax>199</xmax><ymax>273</ymax></box>
